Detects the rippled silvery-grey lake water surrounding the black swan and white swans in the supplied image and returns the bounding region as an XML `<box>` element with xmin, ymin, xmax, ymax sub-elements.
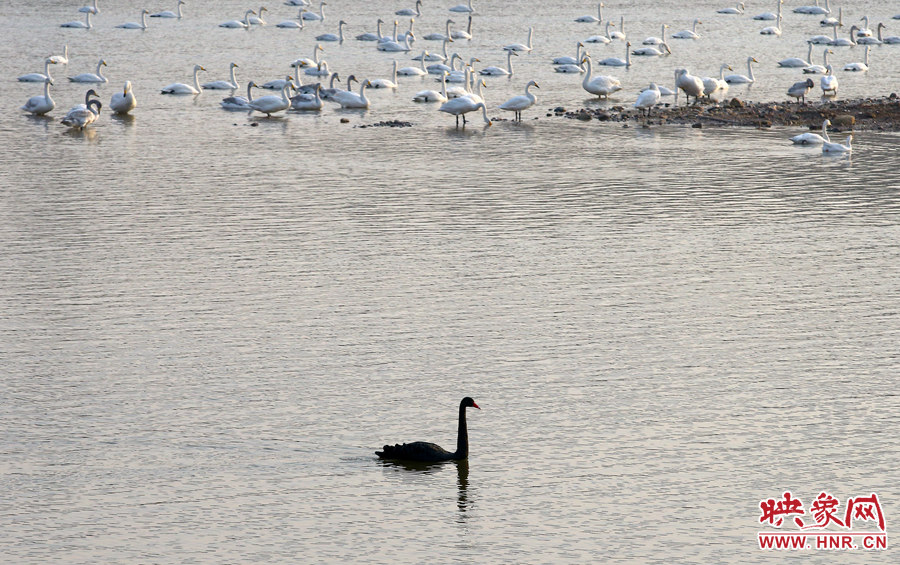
<box><xmin>0</xmin><ymin>0</ymin><xmax>900</xmax><ymax>564</ymax></box>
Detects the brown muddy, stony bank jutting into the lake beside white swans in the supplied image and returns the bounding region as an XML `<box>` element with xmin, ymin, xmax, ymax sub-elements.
<box><xmin>547</xmin><ymin>94</ymin><xmax>900</xmax><ymax>131</ymax></box>
